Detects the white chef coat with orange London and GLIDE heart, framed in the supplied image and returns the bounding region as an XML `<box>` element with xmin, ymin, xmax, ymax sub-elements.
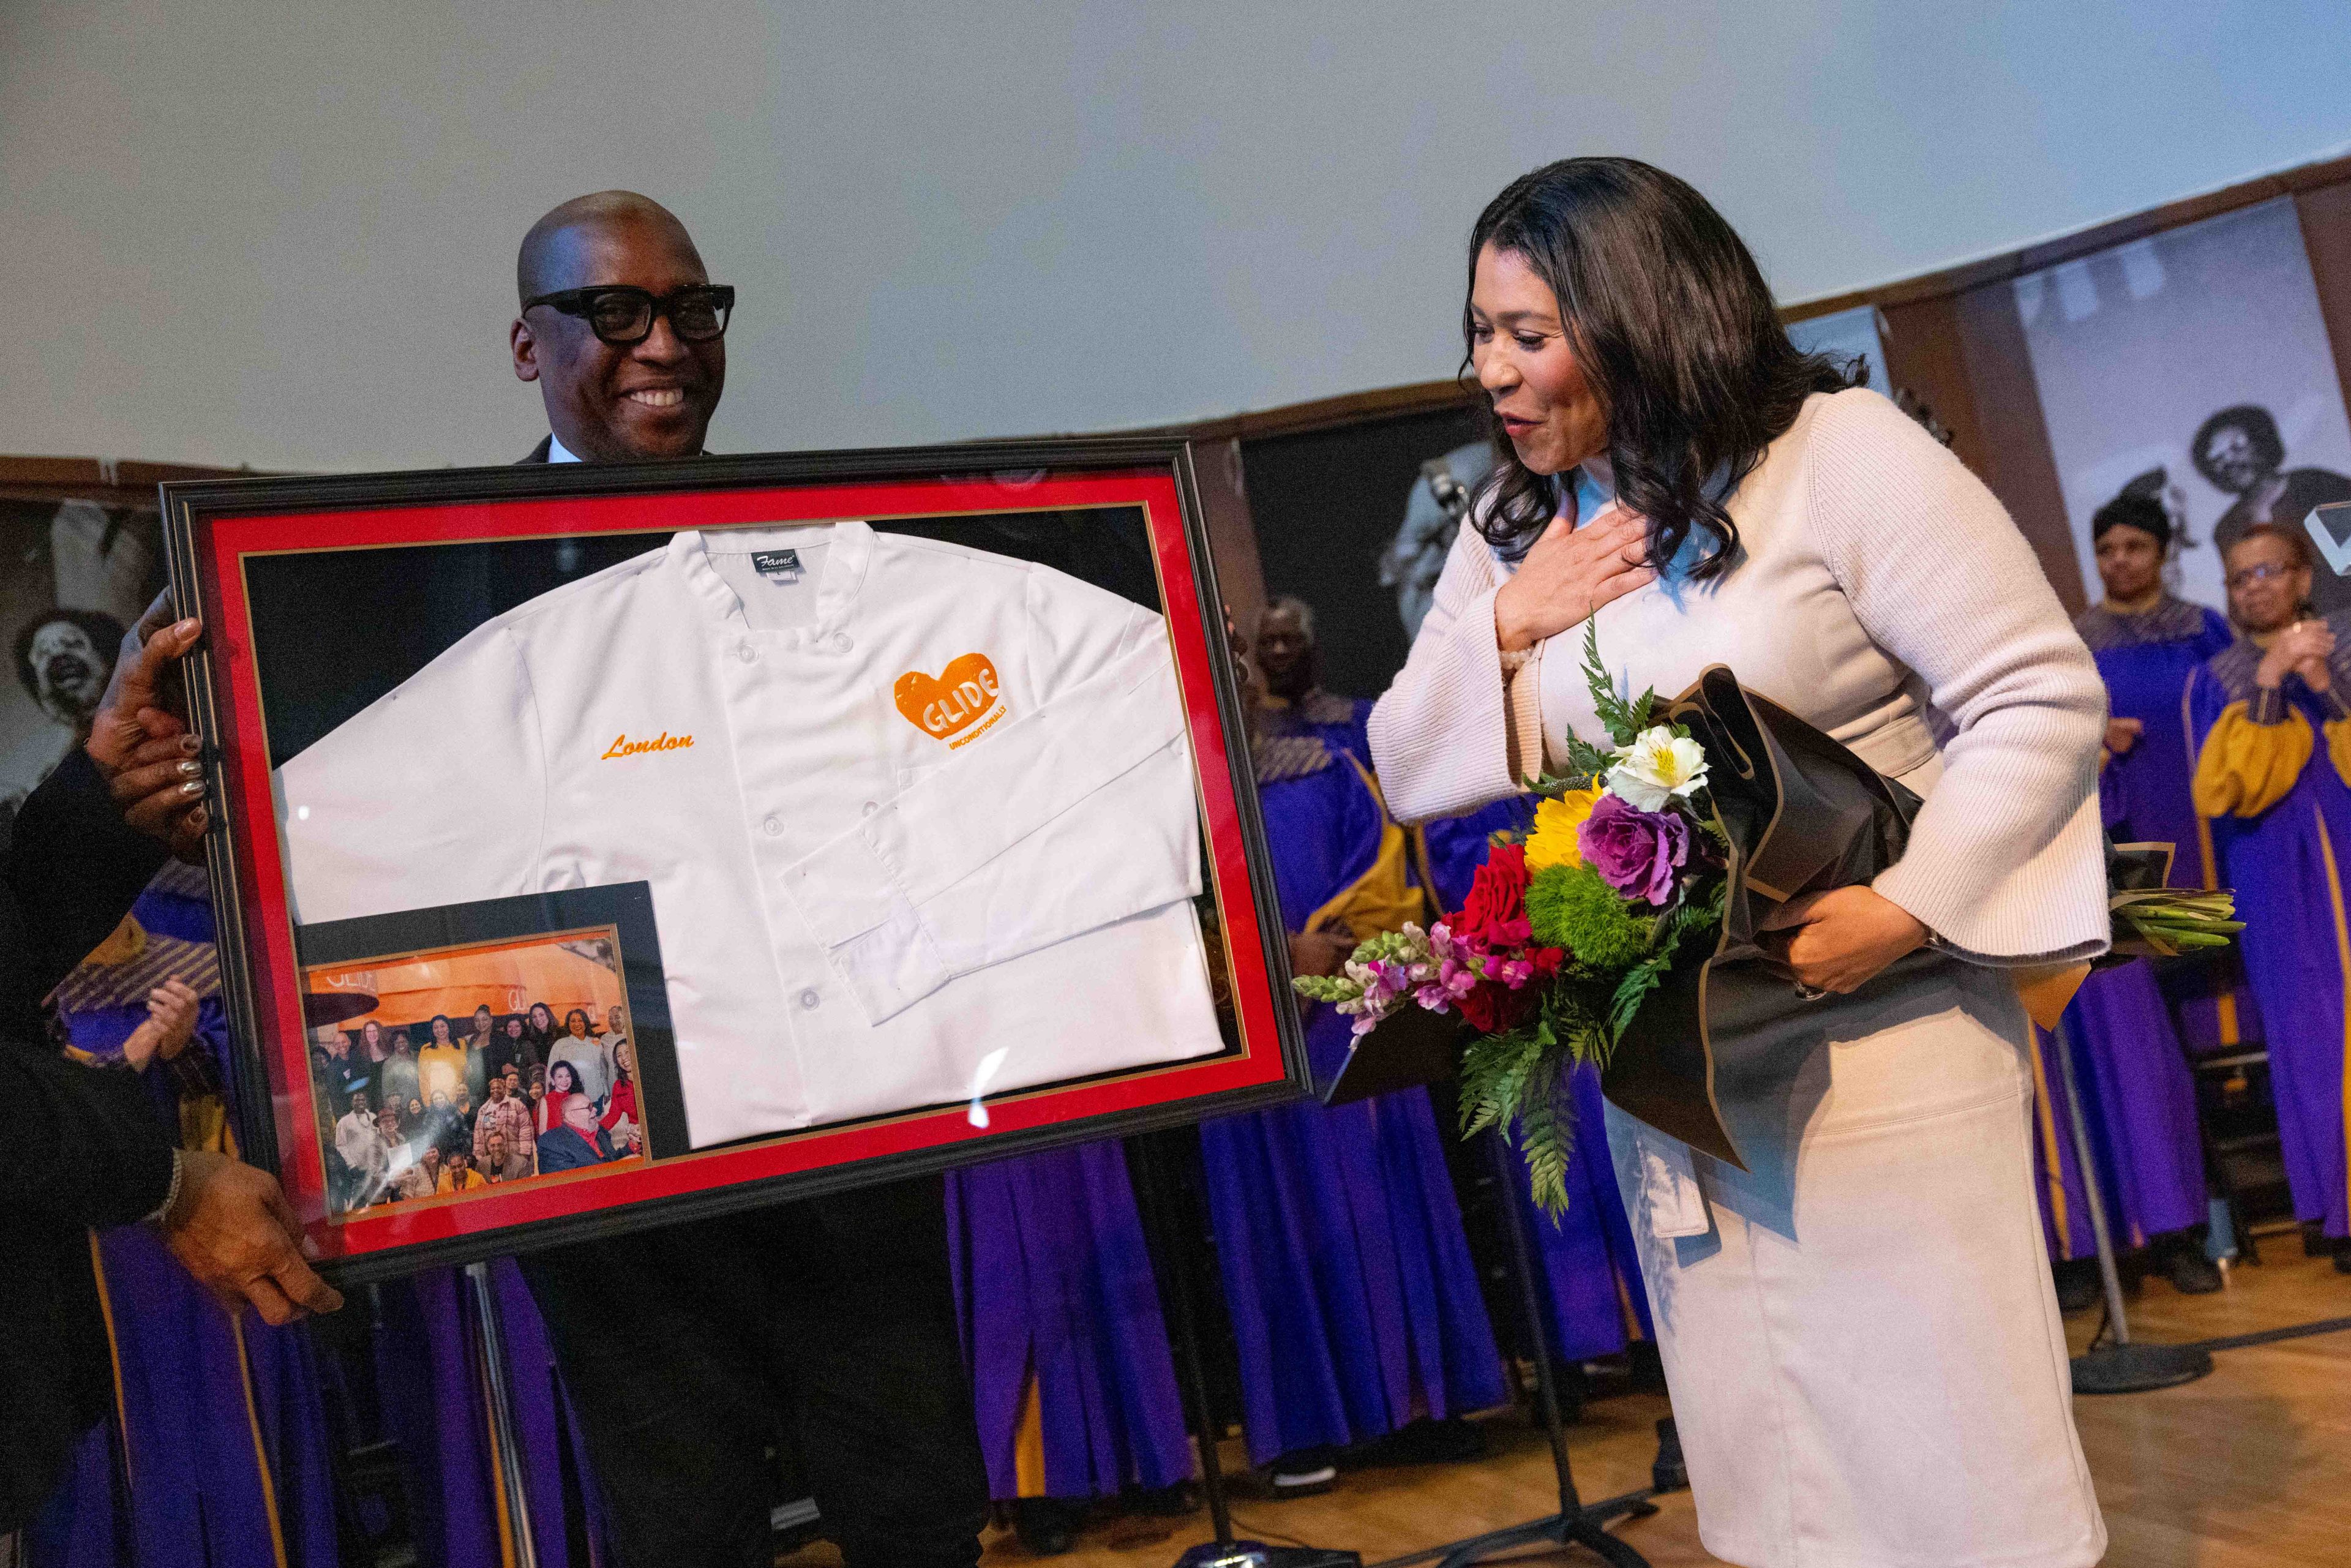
<box><xmin>277</xmin><ymin>522</ymin><xmax>1223</xmax><ymax>1147</ymax></box>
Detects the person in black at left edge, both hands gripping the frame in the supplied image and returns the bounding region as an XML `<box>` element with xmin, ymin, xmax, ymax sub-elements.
<box><xmin>0</xmin><ymin>621</ymin><xmax>343</xmax><ymax>1537</ymax></box>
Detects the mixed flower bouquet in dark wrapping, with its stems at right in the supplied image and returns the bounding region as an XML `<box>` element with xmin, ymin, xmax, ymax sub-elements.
<box><xmin>1293</xmin><ymin>623</ymin><xmax>2238</xmax><ymax>1215</ymax></box>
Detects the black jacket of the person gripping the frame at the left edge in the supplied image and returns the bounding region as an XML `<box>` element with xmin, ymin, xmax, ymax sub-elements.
<box><xmin>0</xmin><ymin>748</ymin><xmax>171</xmax><ymax>1532</ymax></box>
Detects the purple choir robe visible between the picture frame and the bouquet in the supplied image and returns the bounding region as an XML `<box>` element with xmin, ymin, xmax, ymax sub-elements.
<box><xmin>1199</xmin><ymin>736</ymin><xmax>1507</xmax><ymax>1465</ymax></box>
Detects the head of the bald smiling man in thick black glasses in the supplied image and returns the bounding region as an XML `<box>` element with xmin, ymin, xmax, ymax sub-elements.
<box><xmin>508</xmin><ymin>190</ymin><xmax>733</xmax><ymax>463</ymax></box>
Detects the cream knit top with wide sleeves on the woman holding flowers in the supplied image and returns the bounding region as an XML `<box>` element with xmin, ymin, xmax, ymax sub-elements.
<box><xmin>1371</xmin><ymin>390</ymin><xmax>2109</xmax><ymax>964</ymax></box>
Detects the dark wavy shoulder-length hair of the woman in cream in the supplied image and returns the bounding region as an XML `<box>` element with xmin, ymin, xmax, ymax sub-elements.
<box><xmin>1462</xmin><ymin>157</ymin><xmax>1858</xmax><ymax>579</ymax></box>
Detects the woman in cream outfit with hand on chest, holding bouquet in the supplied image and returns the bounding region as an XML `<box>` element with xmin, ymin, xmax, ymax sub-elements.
<box><xmin>1371</xmin><ymin>160</ymin><xmax>2109</xmax><ymax>1568</ymax></box>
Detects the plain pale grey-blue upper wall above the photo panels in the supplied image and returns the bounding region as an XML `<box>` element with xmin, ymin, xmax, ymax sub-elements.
<box><xmin>0</xmin><ymin>0</ymin><xmax>2351</xmax><ymax>468</ymax></box>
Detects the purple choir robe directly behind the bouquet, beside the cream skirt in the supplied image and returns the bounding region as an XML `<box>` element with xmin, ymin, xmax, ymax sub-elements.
<box><xmin>1420</xmin><ymin>795</ymin><xmax>1653</xmax><ymax>1361</ymax></box>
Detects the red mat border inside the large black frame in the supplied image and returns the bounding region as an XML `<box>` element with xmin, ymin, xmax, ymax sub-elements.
<box><xmin>198</xmin><ymin>470</ymin><xmax>1284</xmax><ymax>1258</ymax></box>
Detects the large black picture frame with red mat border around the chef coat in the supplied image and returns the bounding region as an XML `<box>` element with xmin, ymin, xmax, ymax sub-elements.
<box><xmin>160</xmin><ymin>437</ymin><xmax>1312</xmax><ymax>1283</ymax></box>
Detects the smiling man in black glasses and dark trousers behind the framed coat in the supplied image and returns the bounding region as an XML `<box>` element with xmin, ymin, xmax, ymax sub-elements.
<box><xmin>510</xmin><ymin>190</ymin><xmax>988</xmax><ymax>1568</ymax></box>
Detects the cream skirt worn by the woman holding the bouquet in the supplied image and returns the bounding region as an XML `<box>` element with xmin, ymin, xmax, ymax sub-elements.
<box><xmin>1608</xmin><ymin>964</ymin><xmax>2107</xmax><ymax>1568</ymax></box>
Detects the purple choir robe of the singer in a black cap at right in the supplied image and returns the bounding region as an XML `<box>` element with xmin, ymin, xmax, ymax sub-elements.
<box><xmin>2034</xmin><ymin>597</ymin><xmax>2250</xmax><ymax>1258</ymax></box>
